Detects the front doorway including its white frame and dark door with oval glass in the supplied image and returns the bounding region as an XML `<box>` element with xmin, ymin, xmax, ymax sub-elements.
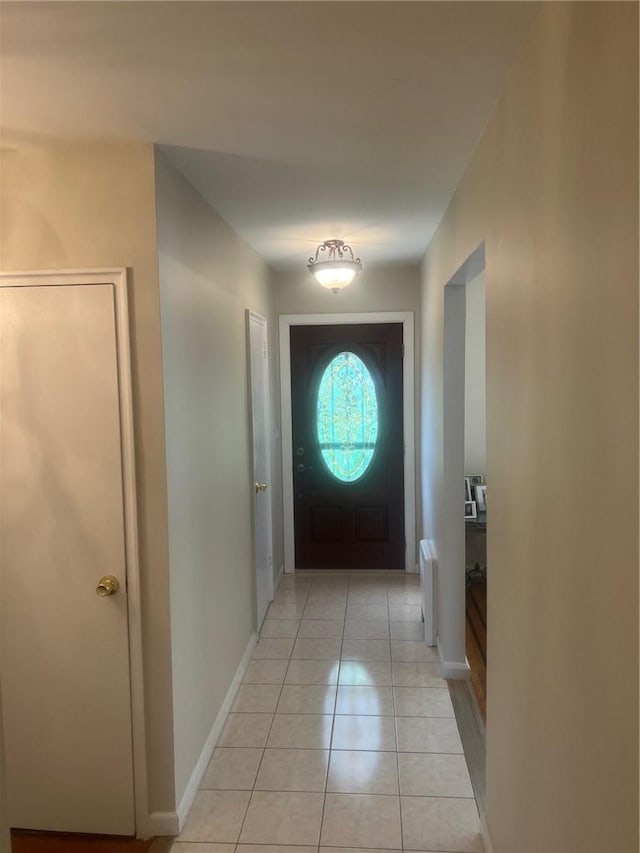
<box><xmin>280</xmin><ymin>312</ymin><xmax>416</xmax><ymax>572</ymax></box>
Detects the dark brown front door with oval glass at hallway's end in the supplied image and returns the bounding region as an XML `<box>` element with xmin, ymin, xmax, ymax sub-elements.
<box><xmin>291</xmin><ymin>323</ymin><xmax>404</xmax><ymax>569</ymax></box>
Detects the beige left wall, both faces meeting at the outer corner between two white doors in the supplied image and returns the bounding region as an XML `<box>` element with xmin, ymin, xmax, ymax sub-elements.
<box><xmin>0</xmin><ymin>144</ymin><xmax>282</xmax><ymax>812</ymax></box>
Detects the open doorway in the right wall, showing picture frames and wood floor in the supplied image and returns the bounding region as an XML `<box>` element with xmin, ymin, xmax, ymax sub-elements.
<box><xmin>438</xmin><ymin>243</ymin><xmax>488</xmax><ymax>808</ymax></box>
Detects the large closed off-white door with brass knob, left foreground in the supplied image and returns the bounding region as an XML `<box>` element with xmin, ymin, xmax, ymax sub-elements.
<box><xmin>0</xmin><ymin>277</ymin><xmax>136</xmax><ymax>835</ymax></box>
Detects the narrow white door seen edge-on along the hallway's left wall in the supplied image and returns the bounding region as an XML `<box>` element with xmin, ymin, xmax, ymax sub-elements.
<box><xmin>247</xmin><ymin>311</ymin><xmax>273</xmax><ymax>629</ymax></box>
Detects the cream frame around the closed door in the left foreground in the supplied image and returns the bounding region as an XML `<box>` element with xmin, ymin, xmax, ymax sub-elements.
<box><xmin>0</xmin><ymin>267</ymin><xmax>149</xmax><ymax>838</ymax></box>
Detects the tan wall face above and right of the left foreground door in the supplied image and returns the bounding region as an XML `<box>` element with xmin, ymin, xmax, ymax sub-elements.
<box><xmin>0</xmin><ymin>144</ymin><xmax>174</xmax><ymax>811</ymax></box>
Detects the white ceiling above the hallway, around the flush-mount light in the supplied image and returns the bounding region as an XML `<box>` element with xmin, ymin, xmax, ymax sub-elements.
<box><xmin>0</xmin><ymin>0</ymin><xmax>537</xmax><ymax>267</ymax></box>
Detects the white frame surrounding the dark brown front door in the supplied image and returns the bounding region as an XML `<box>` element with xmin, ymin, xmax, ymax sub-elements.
<box><xmin>279</xmin><ymin>311</ymin><xmax>417</xmax><ymax>573</ymax></box>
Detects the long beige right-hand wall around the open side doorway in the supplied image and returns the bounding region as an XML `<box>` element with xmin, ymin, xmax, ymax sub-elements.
<box><xmin>422</xmin><ymin>3</ymin><xmax>638</xmax><ymax>853</ymax></box>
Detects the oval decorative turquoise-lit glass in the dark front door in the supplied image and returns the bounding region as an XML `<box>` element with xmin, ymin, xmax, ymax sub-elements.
<box><xmin>316</xmin><ymin>352</ymin><xmax>378</xmax><ymax>483</ymax></box>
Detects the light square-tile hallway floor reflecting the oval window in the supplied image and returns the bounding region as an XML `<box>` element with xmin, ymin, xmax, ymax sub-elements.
<box><xmin>172</xmin><ymin>572</ymin><xmax>482</xmax><ymax>853</ymax></box>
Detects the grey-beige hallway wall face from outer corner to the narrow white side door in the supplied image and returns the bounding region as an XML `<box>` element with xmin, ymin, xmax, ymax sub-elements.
<box><xmin>156</xmin><ymin>152</ymin><xmax>277</xmax><ymax>803</ymax></box>
